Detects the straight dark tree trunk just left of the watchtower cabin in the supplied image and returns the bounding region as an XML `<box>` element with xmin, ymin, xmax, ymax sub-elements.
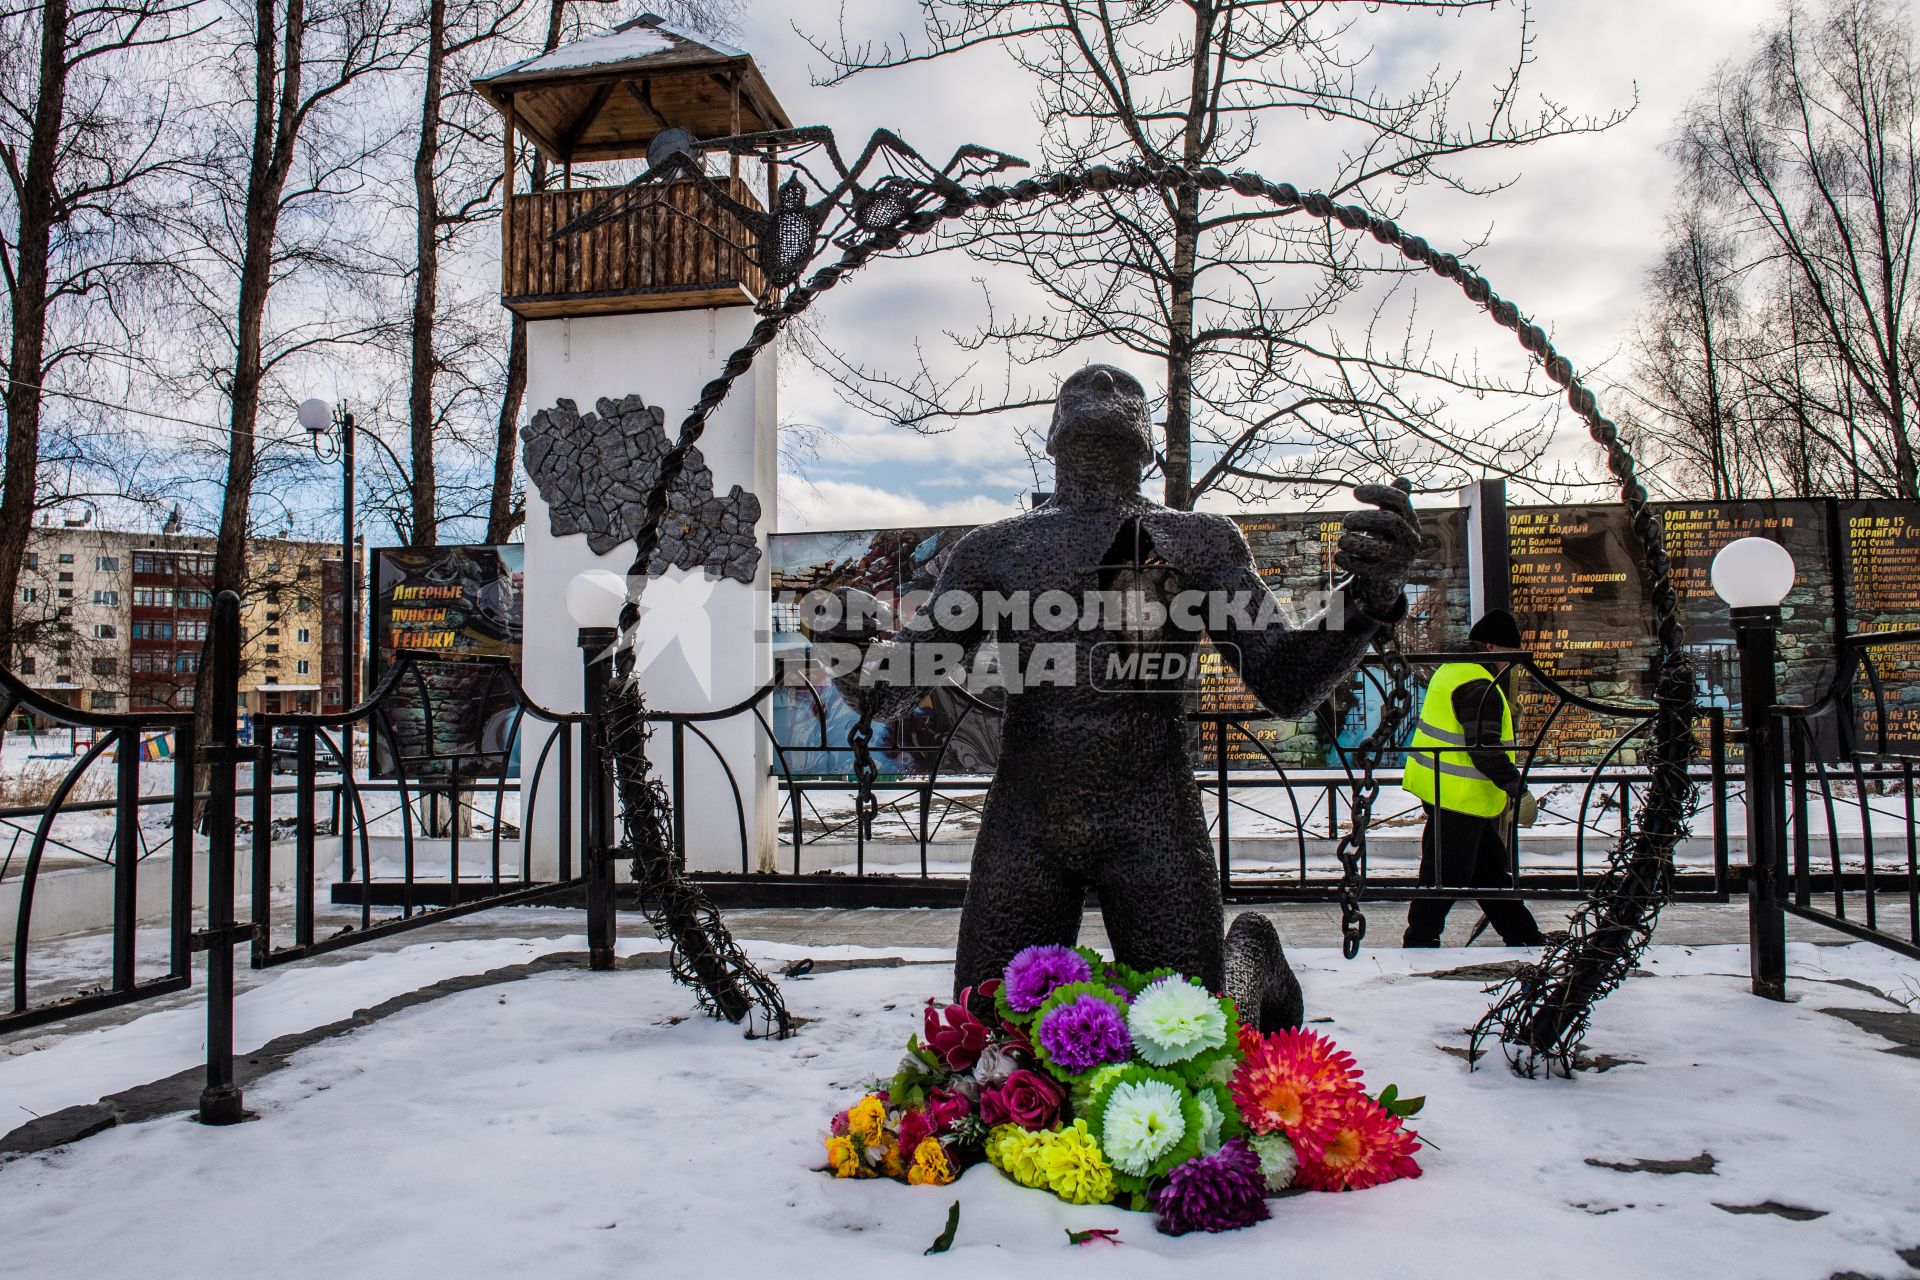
<box><xmin>407</xmin><ymin>0</ymin><xmax>447</xmax><ymax>547</ymax></box>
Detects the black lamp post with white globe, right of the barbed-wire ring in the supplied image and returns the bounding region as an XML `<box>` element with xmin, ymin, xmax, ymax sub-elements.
<box><xmin>1711</xmin><ymin>537</ymin><xmax>1793</xmax><ymax>1000</ymax></box>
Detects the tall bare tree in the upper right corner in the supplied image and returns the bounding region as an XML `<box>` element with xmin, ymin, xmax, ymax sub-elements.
<box><xmin>1678</xmin><ymin>0</ymin><xmax>1920</xmax><ymax>499</ymax></box>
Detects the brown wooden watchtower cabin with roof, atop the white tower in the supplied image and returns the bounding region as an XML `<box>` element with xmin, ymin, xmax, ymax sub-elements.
<box><xmin>474</xmin><ymin>13</ymin><xmax>791</xmax><ymax>319</ymax></box>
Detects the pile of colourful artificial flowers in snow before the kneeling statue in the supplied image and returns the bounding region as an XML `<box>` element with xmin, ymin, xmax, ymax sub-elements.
<box><xmin>828</xmin><ymin>946</ymin><xmax>1421</xmax><ymax>1234</ymax></box>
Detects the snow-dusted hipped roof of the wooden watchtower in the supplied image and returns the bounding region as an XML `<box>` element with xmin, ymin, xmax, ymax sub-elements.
<box><xmin>474</xmin><ymin>13</ymin><xmax>793</xmax><ymax>163</ymax></box>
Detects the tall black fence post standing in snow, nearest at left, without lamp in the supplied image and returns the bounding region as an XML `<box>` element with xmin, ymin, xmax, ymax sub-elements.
<box><xmin>196</xmin><ymin>591</ymin><xmax>257</xmax><ymax>1125</ymax></box>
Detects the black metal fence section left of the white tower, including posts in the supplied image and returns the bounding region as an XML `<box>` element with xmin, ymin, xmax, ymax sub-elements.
<box><xmin>0</xmin><ymin>593</ymin><xmax>612</xmax><ymax>1123</ymax></box>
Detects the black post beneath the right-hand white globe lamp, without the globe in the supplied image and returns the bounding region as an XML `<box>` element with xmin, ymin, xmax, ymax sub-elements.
<box><xmin>1732</xmin><ymin>606</ymin><xmax>1788</xmax><ymax>1000</ymax></box>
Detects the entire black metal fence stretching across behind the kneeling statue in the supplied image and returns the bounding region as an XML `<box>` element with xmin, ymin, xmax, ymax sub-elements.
<box><xmin>15</xmin><ymin>593</ymin><xmax>1920</xmax><ymax>1123</ymax></box>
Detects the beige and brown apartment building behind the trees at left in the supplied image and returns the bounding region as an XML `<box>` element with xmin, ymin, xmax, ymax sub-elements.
<box><xmin>12</xmin><ymin>524</ymin><xmax>365</xmax><ymax>712</ymax></box>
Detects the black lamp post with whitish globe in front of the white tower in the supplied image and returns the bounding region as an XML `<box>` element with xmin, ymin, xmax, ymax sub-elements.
<box><xmin>566</xmin><ymin>568</ymin><xmax>626</xmax><ymax>969</ymax></box>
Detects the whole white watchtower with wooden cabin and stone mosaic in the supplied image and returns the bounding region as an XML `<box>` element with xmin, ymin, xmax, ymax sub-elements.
<box><xmin>474</xmin><ymin>13</ymin><xmax>789</xmax><ymax>877</ymax></box>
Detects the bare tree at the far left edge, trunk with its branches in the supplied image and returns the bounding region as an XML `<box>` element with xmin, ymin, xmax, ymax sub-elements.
<box><xmin>0</xmin><ymin>0</ymin><xmax>192</xmax><ymax>652</ymax></box>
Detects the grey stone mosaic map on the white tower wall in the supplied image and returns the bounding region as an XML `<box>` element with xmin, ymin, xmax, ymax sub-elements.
<box><xmin>520</xmin><ymin>395</ymin><xmax>760</xmax><ymax>583</ymax></box>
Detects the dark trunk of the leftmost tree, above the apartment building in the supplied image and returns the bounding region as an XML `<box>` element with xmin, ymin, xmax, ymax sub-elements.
<box><xmin>0</xmin><ymin>0</ymin><xmax>67</xmax><ymax>664</ymax></box>
